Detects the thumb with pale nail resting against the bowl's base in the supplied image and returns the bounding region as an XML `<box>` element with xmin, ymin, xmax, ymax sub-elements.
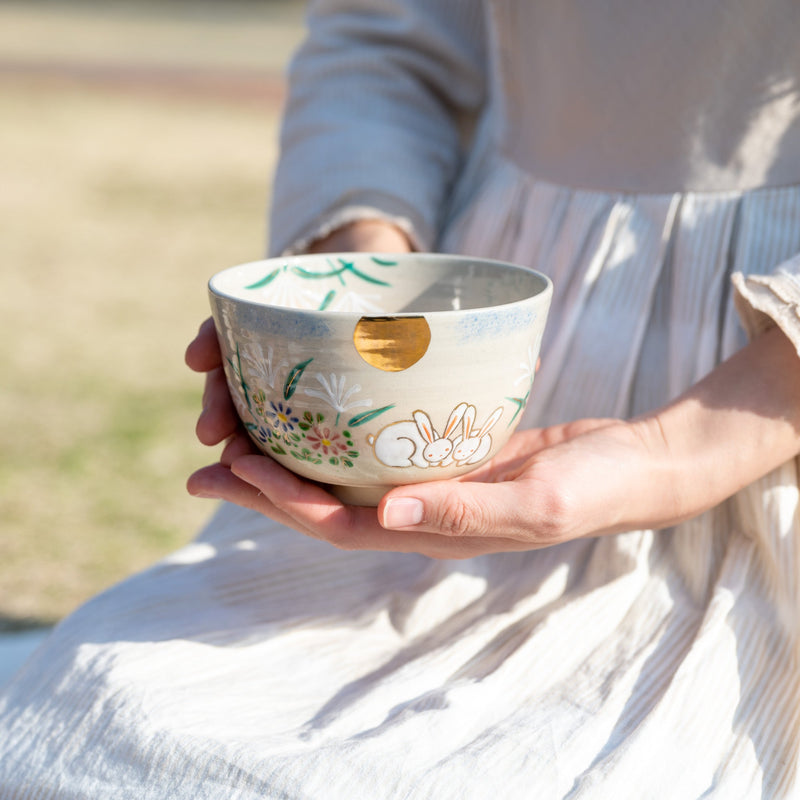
<box><xmin>378</xmin><ymin>481</ymin><xmax>531</xmax><ymax>539</ymax></box>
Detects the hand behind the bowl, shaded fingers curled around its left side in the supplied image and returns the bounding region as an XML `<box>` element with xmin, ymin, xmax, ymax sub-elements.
<box><xmin>186</xmin><ymin>219</ymin><xmax>412</xmax><ymax>456</ymax></box>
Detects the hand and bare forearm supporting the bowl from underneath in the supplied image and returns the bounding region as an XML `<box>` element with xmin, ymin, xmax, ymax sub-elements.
<box><xmin>189</xmin><ymin>330</ymin><xmax>800</xmax><ymax>558</ymax></box>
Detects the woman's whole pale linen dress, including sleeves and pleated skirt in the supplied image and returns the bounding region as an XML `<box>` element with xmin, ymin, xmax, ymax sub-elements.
<box><xmin>0</xmin><ymin>0</ymin><xmax>800</xmax><ymax>800</ymax></box>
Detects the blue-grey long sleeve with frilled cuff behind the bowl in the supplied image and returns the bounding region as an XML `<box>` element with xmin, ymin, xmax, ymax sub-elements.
<box><xmin>270</xmin><ymin>0</ymin><xmax>486</xmax><ymax>254</ymax></box>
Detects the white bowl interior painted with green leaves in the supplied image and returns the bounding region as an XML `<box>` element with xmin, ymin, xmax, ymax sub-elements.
<box><xmin>209</xmin><ymin>253</ymin><xmax>548</xmax><ymax>314</ymax></box>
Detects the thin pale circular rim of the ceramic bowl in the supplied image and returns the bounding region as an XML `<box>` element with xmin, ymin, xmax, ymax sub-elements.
<box><xmin>207</xmin><ymin>250</ymin><xmax>553</xmax><ymax>320</ymax></box>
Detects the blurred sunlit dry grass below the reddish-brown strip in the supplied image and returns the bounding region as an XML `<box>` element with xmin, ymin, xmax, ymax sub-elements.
<box><xmin>0</xmin><ymin>80</ymin><xmax>286</xmax><ymax>620</ymax></box>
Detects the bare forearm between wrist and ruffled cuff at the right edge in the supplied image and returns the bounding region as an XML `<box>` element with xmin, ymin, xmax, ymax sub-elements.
<box><xmin>634</xmin><ymin>328</ymin><xmax>800</xmax><ymax>522</ymax></box>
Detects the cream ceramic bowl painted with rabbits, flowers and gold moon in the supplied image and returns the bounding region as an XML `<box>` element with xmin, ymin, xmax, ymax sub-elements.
<box><xmin>209</xmin><ymin>253</ymin><xmax>552</xmax><ymax>505</ymax></box>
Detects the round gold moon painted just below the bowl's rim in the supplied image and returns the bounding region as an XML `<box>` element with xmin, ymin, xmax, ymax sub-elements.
<box><xmin>353</xmin><ymin>317</ymin><xmax>431</xmax><ymax>372</ymax></box>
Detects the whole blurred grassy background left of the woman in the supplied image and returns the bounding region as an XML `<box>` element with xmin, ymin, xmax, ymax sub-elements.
<box><xmin>0</xmin><ymin>0</ymin><xmax>303</xmax><ymax>632</ymax></box>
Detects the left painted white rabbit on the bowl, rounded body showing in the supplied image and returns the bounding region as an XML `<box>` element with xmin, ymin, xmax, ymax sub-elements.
<box><xmin>367</xmin><ymin>403</ymin><xmax>467</xmax><ymax>468</ymax></box>
